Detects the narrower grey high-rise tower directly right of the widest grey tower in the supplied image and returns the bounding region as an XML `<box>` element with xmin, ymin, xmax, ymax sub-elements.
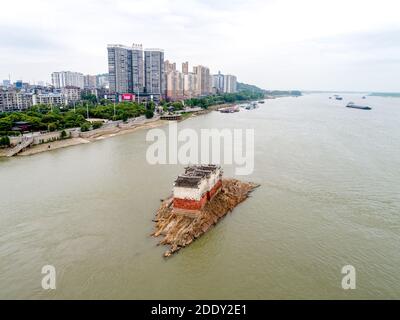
<box><xmin>144</xmin><ymin>49</ymin><xmax>166</xmax><ymax>100</ymax></box>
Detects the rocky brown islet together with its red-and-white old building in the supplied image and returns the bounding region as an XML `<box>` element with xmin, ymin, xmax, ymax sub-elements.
<box><xmin>152</xmin><ymin>165</ymin><xmax>258</xmax><ymax>257</ymax></box>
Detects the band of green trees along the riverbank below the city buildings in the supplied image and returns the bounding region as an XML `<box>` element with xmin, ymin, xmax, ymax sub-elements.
<box><xmin>0</xmin><ymin>91</ymin><xmax>263</xmax><ymax>136</ymax></box>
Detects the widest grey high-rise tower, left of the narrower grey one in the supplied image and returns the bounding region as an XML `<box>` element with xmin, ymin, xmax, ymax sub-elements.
<box><xmin>107</xmin><ymin>44</ymin><xmax>144</xmax><ymax>93</ymax></box>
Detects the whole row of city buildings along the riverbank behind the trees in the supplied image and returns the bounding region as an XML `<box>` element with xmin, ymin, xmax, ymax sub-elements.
<box><xmin>0</xmin><ymin>39</ymin><xmax>237</xmax><ymax>112</ymax></box>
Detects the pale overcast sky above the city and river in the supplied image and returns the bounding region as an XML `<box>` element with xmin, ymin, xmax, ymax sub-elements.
<box><xmin>0</xmin><ymin>0</ymin><xmax>400</xmax><ymax>91</ymax></box>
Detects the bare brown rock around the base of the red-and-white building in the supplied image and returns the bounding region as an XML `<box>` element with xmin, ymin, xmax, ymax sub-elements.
<box><xmin>152</xmin><ymin>179</ymin><xmax>259</xmax><ymax>257</ymax></box>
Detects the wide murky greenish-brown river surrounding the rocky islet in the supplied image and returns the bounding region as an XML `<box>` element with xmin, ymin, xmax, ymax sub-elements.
<box><xmin>0</xmin><ymin>94</ymin><xmax>400</xmax><ymax>299</ymax></box>
